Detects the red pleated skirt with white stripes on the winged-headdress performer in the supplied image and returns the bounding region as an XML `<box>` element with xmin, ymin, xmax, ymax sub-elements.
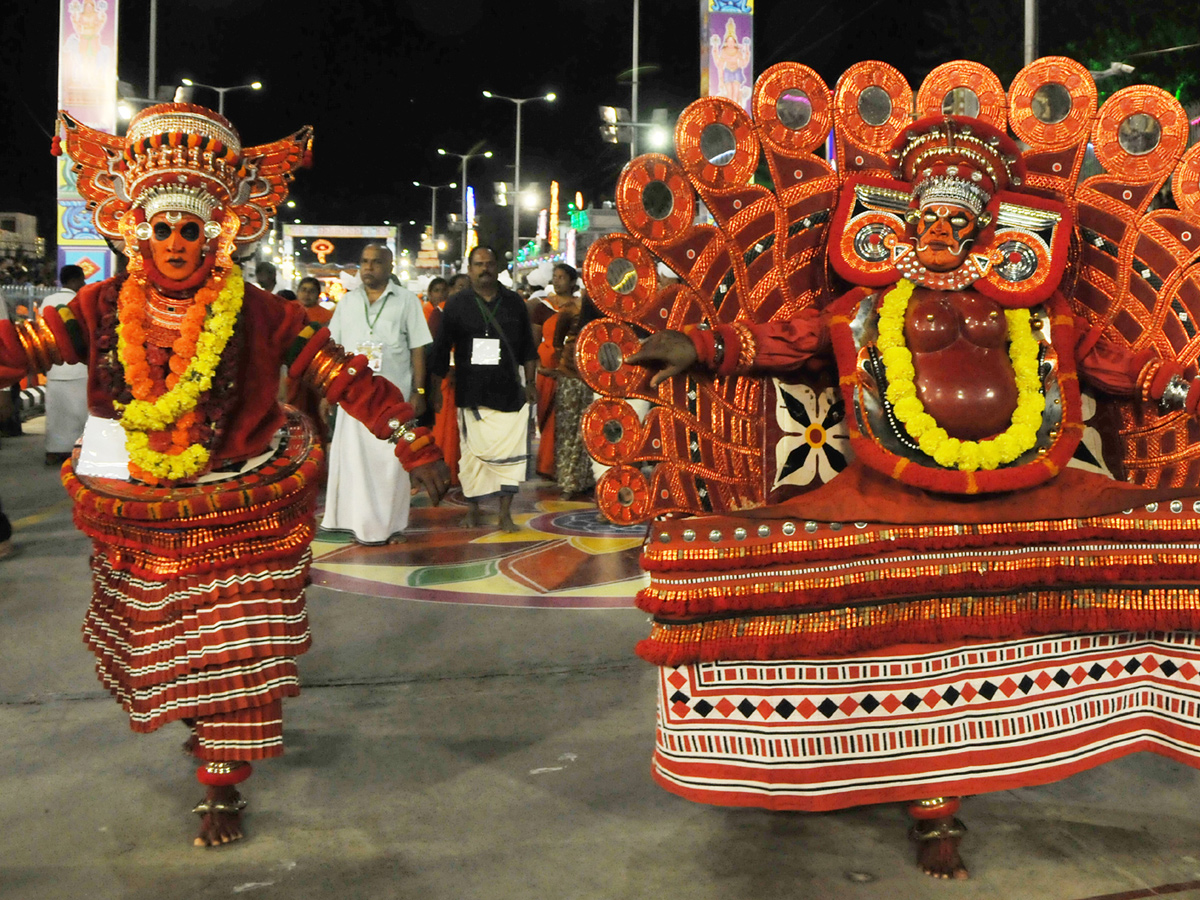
<box><xmin>62</xmin><ymin>413</ymin><xmax>323</xmax><ymax>761</ymax></box>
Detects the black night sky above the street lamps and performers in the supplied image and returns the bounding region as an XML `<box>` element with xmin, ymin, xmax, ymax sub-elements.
<box><xmin>0</xmin><ymin>0</ymin><xmax>1200</xmax><ymax>264</ymax></box>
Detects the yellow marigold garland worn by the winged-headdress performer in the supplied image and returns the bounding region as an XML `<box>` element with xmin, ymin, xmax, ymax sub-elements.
<box><xmin>113</xmin><ymin>266</ymin><xmax>245</xmax><ymax>481</ymax></box>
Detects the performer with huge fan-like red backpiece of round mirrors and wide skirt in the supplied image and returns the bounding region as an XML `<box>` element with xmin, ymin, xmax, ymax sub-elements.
<box><xmin>576</xmin><ymin>58</ymin><xmax>1200</xmax><ymax>877</ymax></box>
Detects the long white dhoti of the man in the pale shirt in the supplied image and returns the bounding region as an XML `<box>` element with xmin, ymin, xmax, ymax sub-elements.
<box><xmin>320</xmin><ymin>409</ymin><xmax>412</xmax><ymax>544</ymax></box>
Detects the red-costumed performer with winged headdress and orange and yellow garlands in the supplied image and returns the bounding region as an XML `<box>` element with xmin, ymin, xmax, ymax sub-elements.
<box><xmin>0</xmin><ymin>103</ymin><xmax>448</xmax><ymax>846</ymax></box>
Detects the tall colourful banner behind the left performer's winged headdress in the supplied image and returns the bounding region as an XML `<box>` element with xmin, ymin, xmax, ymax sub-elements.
<box><xmin>55</xmin><ymin>0</ymin><xmax>118</xmax><ymax>281</ymax></box>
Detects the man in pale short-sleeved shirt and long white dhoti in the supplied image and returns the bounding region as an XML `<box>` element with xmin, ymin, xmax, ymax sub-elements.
<box><xmin>320</xmin><ymin>244</ymin><xmax>432</xmax><ymax>544</ymax></box>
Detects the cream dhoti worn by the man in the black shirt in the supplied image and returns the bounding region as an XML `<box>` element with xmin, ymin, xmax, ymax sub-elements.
<box><xmin>458</xmin><ymin>407</ymin><xmax>529</xmax><ymax>500</ymax></box>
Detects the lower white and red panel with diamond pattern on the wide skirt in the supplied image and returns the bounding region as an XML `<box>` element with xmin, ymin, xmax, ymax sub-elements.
<box><xmin>653</xmin><ymin>632</ymin><xmax>1200</xmax><ymax>811</ymax></box>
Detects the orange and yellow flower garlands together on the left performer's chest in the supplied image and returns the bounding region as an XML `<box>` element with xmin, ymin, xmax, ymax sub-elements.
<box><xmin>113</xmin><ymin>266</ymin><xmax>245</xmax><ymax>482</ymax></box>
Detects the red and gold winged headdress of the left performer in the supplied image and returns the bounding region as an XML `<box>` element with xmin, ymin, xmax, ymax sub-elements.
<box><xmin>54</xmin><ymin>103</ymin><xmax>312</xmax><ymax>245</ymax></box>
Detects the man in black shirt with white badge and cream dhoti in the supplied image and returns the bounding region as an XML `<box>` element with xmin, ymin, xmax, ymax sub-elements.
<box><xmin>430</xmin><ymin>247</ymin><xmax>538</xmax><ymax>532</ymax></box>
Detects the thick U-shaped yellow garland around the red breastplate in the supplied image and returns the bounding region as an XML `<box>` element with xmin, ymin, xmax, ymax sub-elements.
<box><xmin>876</xmin><ymin>278</ymin><xmax>1045</xmax><ymax>472</ymax></box>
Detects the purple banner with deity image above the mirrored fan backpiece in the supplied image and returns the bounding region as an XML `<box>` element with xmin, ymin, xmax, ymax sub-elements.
<box><xmin>700</xmin><ymin>0</ymin><xmax>754</xmax><ymax>113</ymax></box>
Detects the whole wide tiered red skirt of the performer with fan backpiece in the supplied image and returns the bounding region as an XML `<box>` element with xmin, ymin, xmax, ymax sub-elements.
<box><xmin>638</xmin><ymin>499</ymin><xmax>1200</xmax><ymax>811</ymax></box>
